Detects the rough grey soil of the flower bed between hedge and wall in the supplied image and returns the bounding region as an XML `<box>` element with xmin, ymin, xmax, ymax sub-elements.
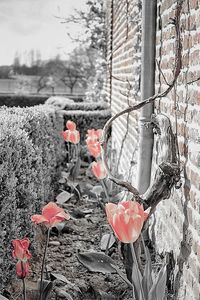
<box><xmin>6</xmin><ymin>165</ymin><xmax>133</xmax><ymax>300</ymax></box>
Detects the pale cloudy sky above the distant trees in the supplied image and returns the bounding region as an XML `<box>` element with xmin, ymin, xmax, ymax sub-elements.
<box><xmin>0</xmin><ymin>0</ymin><xmax>86</xmax><ymax>65</ymax></box>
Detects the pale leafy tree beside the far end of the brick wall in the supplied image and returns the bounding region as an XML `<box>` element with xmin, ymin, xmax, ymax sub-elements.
<box><xmin>65</xmin><ymin>0</ymin><xmax>106</xmax><ymax>102</ymax></box>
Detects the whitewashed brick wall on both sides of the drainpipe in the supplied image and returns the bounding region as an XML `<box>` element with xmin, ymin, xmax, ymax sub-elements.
<box><xmin>106</xmin><ymin>0</ymin><xmax>200</xmax><ymax>300</ymax></box>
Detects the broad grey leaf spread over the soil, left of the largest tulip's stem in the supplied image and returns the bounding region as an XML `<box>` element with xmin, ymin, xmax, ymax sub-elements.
<box><xmin>77</xmin><ymin>252</ymin><xmax>116</xmax><ymax>274</ymax></box>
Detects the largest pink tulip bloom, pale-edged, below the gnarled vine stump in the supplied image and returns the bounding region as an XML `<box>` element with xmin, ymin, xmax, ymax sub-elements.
<box><xmin>105</xmin><ymin>200</ymin><xmax>148</xmax><ymax>243</ymax></box>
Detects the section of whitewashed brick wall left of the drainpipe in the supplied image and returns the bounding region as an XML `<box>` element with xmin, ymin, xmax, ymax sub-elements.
<box><xmin>106</xmin><ymin>0</ymin><xmax>141</xmax><ymax>183</ymax></box>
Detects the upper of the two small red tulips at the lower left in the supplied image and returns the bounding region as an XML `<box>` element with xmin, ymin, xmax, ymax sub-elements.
<box><xmin>12</xmin><ymin>238</ymin><xmax>31</xmax><ymax>261</ymax></box>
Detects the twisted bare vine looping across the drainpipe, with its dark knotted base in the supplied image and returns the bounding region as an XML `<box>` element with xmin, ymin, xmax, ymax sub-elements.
<box><xmin>100</xmin><ymin>0</ymin><xmax>184</xmax><ymax>214</ymax></box>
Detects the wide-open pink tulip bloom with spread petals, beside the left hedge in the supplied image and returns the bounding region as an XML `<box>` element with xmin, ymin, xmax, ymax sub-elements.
<box><xmin>31</xmin><ymin>202</ymin><xmax>70</xmax><ymax>228</ymax></box>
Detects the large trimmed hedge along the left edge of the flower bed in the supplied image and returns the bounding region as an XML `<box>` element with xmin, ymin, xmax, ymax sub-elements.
<box><xmin>0</xmin><ymin>105</ymin><xmax>65</xmax><ymax>289</ymax></box>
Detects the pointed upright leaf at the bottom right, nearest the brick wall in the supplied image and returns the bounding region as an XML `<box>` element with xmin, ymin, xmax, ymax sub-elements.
<box><xmin>149</xmin><ymin>265</ymin><xmax>167</xmax><ymax>300</ymax></box>
